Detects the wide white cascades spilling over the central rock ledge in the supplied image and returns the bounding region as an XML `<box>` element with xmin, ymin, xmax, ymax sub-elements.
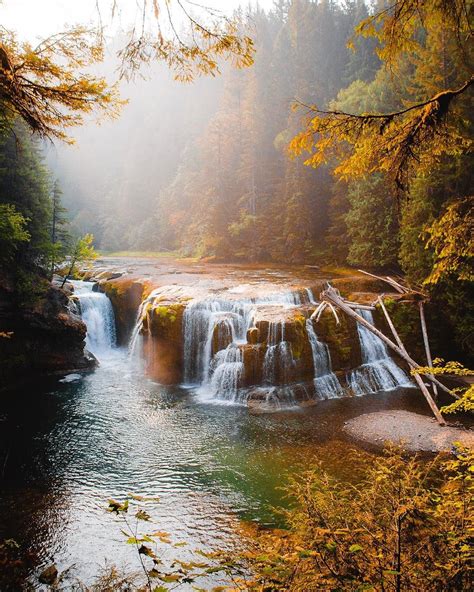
<box><xmin>128</xmin><ymin>285</ymin><xmax>410</xmax><ymax>408</ymax></box>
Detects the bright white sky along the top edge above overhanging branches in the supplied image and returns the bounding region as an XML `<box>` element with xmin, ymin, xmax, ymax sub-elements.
<box><xmin>0</xmin><ymin>0</ymin><xmax>273</xmax><ymax>40</ymax></box>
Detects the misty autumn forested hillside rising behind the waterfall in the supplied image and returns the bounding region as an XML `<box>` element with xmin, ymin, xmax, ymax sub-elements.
<box><xmin>52</xmin><ymin>0</ymin><xmax>472</xmax><ymax>352</ymax></box>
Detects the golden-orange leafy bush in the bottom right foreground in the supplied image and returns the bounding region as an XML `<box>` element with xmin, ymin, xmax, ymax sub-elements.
<box><xmin>230</xmin><ymin>449</ymin><xmax>474</xmax><ymax>592</ymax></box>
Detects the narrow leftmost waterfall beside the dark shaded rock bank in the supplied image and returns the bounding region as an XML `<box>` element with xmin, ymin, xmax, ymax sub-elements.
<box><xmin>73</xmin><ymin>281</ymin><xmax>116</xmax><ymax>358</ymax></box>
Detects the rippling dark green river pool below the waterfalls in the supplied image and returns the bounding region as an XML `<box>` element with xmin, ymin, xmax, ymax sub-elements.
<box><xmin>0</xmin><ymin>350</ymin><xmax>428</xmax><ymax>582</ymax></box>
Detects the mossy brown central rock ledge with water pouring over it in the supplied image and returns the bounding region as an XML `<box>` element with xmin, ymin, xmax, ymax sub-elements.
<box><xmin>92</xmin><ymin>262</ymin><xmax>412</xmax><ymax>407</ymax></box>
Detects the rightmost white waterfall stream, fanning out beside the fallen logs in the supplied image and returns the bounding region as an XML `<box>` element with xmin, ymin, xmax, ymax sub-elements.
<box><xmin>348</xmin><ymin>310</ymin><xmax>412</xmax><ymax>396</ymax></box>
